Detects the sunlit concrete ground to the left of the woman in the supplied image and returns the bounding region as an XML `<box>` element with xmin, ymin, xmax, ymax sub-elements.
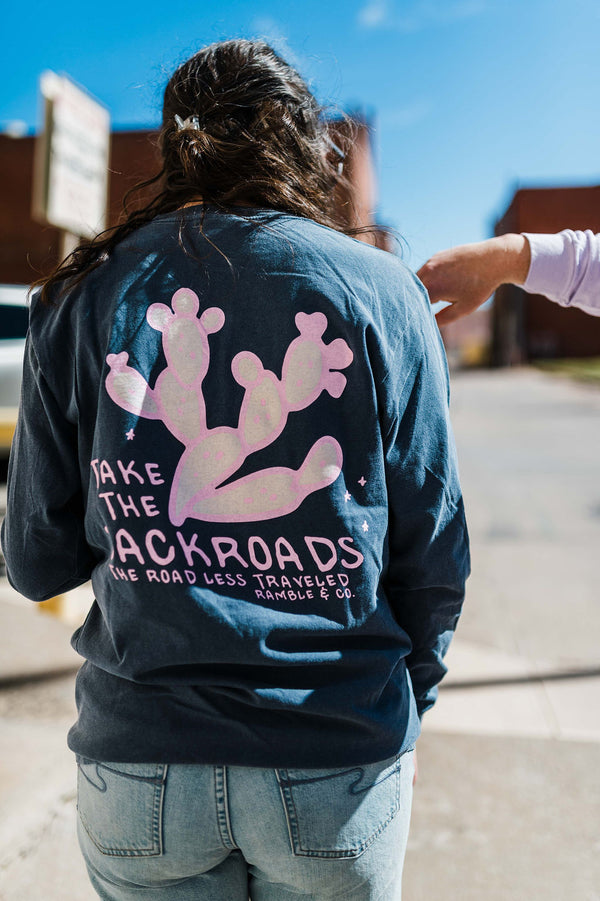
<box><xmin>0</xmin><ymin>580</ymin><xmax>96</xmax><ymax>901</ymax></box>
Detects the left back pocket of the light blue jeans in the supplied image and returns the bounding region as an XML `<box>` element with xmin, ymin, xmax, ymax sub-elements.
<box><xmin>77</xmin><ymin>757</ymin><xmax>168</xmax><ymax>857</ymax></box>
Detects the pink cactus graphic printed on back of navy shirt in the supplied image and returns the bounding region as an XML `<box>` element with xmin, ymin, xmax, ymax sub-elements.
<box><xmin>106</xmin><ymin>288</ymin><xmax>352</xmax><ymax>526</ymax></box>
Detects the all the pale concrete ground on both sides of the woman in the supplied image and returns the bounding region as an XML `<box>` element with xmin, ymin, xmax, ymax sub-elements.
<box><xmin>0</xmin><ymin>370</ymin><xmax>600</xmax><ymax>901</ymax></box>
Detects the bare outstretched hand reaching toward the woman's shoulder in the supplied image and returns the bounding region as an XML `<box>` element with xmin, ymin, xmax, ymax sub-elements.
<box><xmin>417</xmin><ymin>235</ymin><xmax>531</xmax><ymax>325</ymax></box>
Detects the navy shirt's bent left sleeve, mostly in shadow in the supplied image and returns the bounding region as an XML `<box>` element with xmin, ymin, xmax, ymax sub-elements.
<box><xmin>2</xmin><ymin>335</ymin><xmax>94</xmax><ymax>601</ymax></box>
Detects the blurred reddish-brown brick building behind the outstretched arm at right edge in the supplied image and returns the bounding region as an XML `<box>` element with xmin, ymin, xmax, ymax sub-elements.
<box><xmin>492</xmin><ymin>186</ymin><xmax>600</xmax><ymax>366</ymax></box>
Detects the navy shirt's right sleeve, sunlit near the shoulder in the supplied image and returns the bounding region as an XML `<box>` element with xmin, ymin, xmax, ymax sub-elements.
<box><xmin>385</xmin><ymin>278</ymin><xmax>470</xmax><ymax>716</ymax></box>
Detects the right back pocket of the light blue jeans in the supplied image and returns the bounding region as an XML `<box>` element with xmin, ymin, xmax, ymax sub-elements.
<box><xmin>276</xmin><ymin>755</ymin><xmax>401</xmax><ymax>858</ymax></box>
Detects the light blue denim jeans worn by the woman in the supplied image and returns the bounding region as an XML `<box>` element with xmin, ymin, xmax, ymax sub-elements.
<box><xmin>78</xmin><ymin>751</ymin><xmax>414</xmax><ymax>901</ymax></box>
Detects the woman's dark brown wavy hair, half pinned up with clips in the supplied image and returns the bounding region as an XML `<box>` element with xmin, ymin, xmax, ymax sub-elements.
<box><xmin>34</xmin><ymin>40</ymin><xmax>365</xmax><ymax>303</ymax></box>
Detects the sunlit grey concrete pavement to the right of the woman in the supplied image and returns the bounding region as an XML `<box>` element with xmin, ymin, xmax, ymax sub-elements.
<box><xmin>404</xmin><ymin>369</ymin><xmax>600</xmax><ymax>901</ymax></box>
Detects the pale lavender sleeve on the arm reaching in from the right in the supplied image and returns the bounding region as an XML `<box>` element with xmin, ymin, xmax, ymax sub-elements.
<box><xmin>523</xmin><ymin>229</ymin><xmax>600</xmax><ymax>316</ymax></box>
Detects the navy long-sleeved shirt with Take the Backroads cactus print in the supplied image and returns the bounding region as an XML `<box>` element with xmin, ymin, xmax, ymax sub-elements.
<box><xmin>2</xmin><ymin>206</ymin><xmax>469</xmax><ymax>767</ymax></box>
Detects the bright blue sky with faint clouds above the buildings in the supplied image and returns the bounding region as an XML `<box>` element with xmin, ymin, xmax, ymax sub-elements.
<box><xmin>0</xmin><ymin>0</ymin><xmax>600</xmax><ymax>267</ymax></box>
